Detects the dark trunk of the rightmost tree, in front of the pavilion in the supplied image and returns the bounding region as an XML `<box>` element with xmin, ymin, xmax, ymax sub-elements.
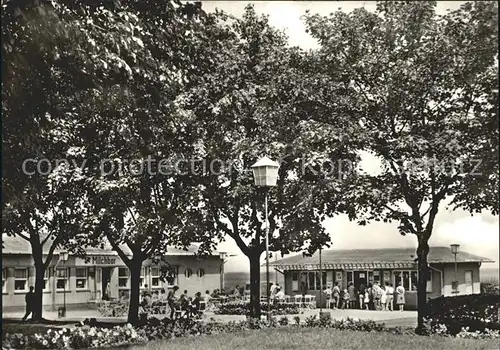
<box><xmin>415</xmin><ymin>238</ymin><xmax>429</xmax><ymax>335</ymax></box>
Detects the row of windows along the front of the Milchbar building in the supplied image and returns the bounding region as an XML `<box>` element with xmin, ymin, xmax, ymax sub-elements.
<box><xmin>2</xmin><ymin>266</ymin><xmax>205</xmax><ymax>293</ymax></box>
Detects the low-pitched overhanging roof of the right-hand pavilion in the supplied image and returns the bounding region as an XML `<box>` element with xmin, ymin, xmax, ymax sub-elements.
<box><xmin>269</xmin><ymin>247</ymin><xmax>493</xmax><ymax>269</ymax></box>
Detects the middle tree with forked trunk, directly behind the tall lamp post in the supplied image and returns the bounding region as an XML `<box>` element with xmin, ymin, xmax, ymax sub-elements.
<box><xmin>183</xmin><ymin>5</ymin><xmax>360</xmax><ymax>317</ymax></box>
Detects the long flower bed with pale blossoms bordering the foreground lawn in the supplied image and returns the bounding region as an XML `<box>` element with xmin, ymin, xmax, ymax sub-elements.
<box><xmin>3</xmin><ymin>315</ymin><xmax>500</xmax><ymax>349</ymax></box>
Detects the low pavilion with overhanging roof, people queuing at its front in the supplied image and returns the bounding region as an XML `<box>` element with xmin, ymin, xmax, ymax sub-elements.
<box><xmin>270</xmin><ymin>247</ymin><xmax>493</xmax><ymax>309</ymax></box>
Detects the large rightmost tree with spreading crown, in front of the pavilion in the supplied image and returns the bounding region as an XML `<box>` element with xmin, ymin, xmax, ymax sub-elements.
<box><xmin>306</xmin><ymin>2</ymin><xmax>498</xmax><ymax>334</ymax></box>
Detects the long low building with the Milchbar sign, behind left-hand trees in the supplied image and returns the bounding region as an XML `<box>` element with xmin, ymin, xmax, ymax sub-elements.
<box><xmin>2</xmin><ymin>237</ymin><xmax>222</xmax><ymax>310</ymax></box>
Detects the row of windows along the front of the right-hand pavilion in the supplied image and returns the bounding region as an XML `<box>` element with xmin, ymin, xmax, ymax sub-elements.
<box><xmin>292</xmin><ymin>270</ymin><xmax>432</xmax><ymax>292</ymax></box>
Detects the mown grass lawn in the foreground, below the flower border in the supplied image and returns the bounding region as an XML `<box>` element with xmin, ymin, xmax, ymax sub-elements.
<box><xmin>124</xmin><ymin>328</ymin><xmax>498</xmax><ymax>350</ymax></box>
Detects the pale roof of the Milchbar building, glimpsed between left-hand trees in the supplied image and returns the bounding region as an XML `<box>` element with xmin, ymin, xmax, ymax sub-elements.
<box><xmin>2</xmin><ymin>235</ymin><xmax>213</xmax><ymax>255</ymax></box>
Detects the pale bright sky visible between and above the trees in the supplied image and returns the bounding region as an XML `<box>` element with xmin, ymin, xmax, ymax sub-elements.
<box><xmin>203</xmin><ymin>1</ymin><xmax>500</xmax><ymax>272</ymax></box>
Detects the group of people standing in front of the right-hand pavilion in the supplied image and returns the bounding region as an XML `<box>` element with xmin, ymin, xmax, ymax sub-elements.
<box><xmin>324</xmin><ymin>281</ymin><xmax>406</xmax><ymax>311</ymax></box>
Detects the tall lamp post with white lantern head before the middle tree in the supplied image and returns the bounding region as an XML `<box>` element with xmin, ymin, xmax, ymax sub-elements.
<box><xmin>251</xmin><ymin>157</ymin><xmax>279</xmax><ymax>321</ymax></box>
